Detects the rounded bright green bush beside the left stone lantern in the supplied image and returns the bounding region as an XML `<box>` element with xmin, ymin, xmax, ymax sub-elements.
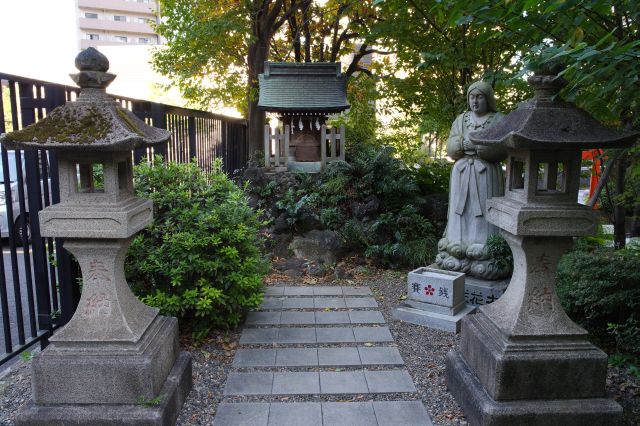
<box><xmin>126</xmin><ymin>157</ymin><xmax>267</xmax><ymax>336</ymax></box>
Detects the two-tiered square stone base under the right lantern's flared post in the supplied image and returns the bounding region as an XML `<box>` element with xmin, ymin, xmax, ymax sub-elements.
<box><xmin>445</xmin><ymin>310</ymin><xmax>622</xmax><ymax>426</ymax></box>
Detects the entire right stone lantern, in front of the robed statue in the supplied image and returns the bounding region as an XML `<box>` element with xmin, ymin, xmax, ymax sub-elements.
<box><xmin>446</xmin><ymin>68</ymin><xmax>638</xmax><ymax>426</ymax></box>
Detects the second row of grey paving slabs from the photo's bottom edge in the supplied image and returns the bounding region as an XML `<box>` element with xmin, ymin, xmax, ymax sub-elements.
<box><xmin>224</xmin><ymin>370</ymin><xmax>416</xmax><ymax>395</ymax></box>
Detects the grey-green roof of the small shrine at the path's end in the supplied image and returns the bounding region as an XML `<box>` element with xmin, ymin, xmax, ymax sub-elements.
<box><xmin>258</xmin><ymin>62</ymin><xmax>349</xmax><ymax>114</ymax></box>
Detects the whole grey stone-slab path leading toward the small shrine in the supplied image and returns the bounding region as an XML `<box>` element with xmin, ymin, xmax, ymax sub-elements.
<box><xmin>213</xmin><ymin>286</ymin><xmax>432</xmax><ymax>426</ymax></box>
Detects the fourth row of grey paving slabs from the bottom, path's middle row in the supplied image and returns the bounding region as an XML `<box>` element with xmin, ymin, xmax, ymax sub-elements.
<box><xmin>240</xmin><ymin>327</ymin><xmax>393</xmax><ymax>345</ymax></box>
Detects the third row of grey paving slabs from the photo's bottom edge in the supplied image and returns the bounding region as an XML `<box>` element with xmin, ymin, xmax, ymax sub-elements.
<box><xmin>232</xmin><ymin>346</ymin><xmax>404</xmax><ymax>368</ymax></box>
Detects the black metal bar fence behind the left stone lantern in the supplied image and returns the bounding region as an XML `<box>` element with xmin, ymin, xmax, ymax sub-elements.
<box><xmin>0</xmin><ymin>73</ymin><xmax>248</xmax><ymax>366</ymax></box>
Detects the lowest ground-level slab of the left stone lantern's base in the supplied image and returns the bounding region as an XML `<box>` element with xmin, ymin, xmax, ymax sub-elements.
<box><xmin>16</xmin><ymin>352</ymin><xmax>192</xmax><ymax>426</ymax></box>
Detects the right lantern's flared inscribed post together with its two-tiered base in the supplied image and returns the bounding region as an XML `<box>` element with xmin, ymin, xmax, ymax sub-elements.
<box><xmin>446</xmin><ymin>231</ymin><xmax>622</xmax><ymax>426</ymax></box>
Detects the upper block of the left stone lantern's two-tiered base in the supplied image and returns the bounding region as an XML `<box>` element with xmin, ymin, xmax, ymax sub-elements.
<box><xmin>33</xmin><ymin>316</ymin><xmax>179</xmax><ymax>405</ymax></box>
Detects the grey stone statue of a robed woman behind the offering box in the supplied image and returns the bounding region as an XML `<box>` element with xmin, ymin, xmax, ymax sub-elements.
<box><xmin>436</xmin><ymin>81</ymin><xmax>511</xmax><ymax>280</ymax></box>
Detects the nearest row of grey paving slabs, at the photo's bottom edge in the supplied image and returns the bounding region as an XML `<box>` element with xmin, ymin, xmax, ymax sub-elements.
<box><xmin>213</xmin><ymin>401</ymin><xmax>433</xmax><ymax>426</ymax></box>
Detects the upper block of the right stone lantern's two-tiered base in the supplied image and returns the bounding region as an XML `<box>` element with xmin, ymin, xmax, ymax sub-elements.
<box><xmin>460</xmin><ymin>312</ymin><xmax>607</xmax><ymax>401</ymax></box>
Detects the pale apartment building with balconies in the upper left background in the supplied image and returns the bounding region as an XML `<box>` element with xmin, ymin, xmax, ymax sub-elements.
<box><xmin>77</xmin><ymin>0</ymin><xmax>162</xmax><ymax>49</ymax></box>
